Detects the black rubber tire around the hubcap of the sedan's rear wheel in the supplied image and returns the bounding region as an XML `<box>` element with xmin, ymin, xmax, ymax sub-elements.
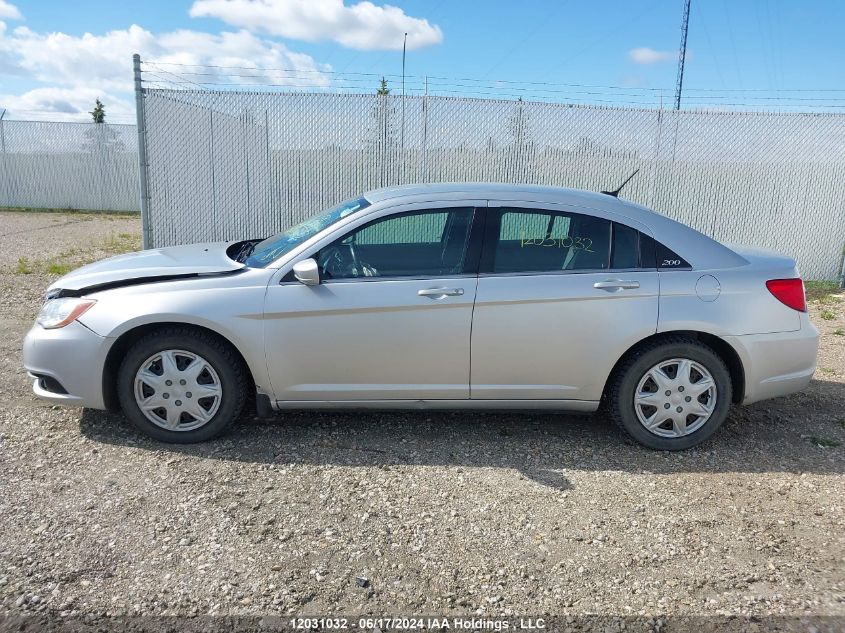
<box><xmin>607</xmin><ymin>337</ymin><xmax>732</xmax><ymax>451</ymax></box>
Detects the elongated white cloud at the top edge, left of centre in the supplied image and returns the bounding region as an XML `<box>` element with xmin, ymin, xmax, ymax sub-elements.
<box><xmin>190</xmin><ymin>0</ymin><xmax>443</xmax><ymax>50</ymax></box>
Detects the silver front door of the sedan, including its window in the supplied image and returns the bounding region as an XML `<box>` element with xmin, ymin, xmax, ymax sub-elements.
<box><xmin>264</xmin><ymin>201</ymin><xmax>484</xmax><ymax>401</ymax></box>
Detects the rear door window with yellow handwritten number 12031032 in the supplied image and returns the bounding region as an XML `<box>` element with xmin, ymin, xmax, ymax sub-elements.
<box><xmin>487</xmin><ymin>209</ymin><xmax>612</xmax><ymax>273</ymax></box>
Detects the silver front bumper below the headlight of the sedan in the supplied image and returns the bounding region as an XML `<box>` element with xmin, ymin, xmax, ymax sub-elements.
<box><xmin>23</xmin><ymin>321</ymin><xmax>108</xmax><ymax>409</ymax></box>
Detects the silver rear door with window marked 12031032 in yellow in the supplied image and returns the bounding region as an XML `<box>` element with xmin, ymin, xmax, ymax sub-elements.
<box><xmin>471</xmin><ymin>201</ymin><xmax>659</xmax><ymax>401</ymax></box>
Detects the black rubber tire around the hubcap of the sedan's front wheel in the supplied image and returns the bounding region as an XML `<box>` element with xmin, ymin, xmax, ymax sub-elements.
<box><xmin>117</xmin><ymin>326</ymin><xmax>249</xmax><ymax>444</ymax></box>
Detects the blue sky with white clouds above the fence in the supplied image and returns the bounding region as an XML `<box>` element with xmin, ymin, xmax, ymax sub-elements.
<box><xmin>0</xmin><ymin>0</ymin><xmax>845</xmax><ymax>121</ymax></box>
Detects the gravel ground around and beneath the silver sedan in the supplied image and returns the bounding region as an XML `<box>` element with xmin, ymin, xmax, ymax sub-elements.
<box><xmin>0</xmin><ymin>213</ymin><xmax>845</xmax><ymax>630</ymax></box>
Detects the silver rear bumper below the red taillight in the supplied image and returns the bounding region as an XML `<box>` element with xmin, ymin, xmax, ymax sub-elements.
<box><xmin>725</xmin><ymin>314</ymin><xmax>819</xmax><ymax>404</ymax></box>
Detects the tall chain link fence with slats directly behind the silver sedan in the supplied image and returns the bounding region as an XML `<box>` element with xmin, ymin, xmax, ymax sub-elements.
<box><xmin>138</xmin><ymin>88</ymin><xmax>845</xmax><ymax>279</ymax></box>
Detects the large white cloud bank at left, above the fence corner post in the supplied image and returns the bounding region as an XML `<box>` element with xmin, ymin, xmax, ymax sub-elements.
<box><xmin>0</xmin><ymin>22</ymin><xmax>329</xmax><ymax>119</ymax></box>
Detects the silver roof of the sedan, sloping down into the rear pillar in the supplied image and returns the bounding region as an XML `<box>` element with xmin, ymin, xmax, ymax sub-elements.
<box><xmin>364</xmin><ymin>182</ymin><xmax>748</xmax><ymax>268</ymax></box>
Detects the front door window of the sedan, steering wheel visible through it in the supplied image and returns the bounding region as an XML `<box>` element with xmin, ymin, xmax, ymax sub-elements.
<box><xmin>316</xmin><ymin>208</ymin><xmax>473</xmax><ymax>279</ymax></box>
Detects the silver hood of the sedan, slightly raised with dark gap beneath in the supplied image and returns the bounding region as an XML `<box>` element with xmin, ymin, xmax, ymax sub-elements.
<box><xmin>50</xmin><ymin>242</ymin><xmax>244</xmax><ymax>291</ymax></box>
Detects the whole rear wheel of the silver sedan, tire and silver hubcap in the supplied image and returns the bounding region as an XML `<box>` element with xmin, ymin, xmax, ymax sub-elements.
<box><xmin>609</xmin><ymin>338</ymin><xmax>732</xmax><ymax>451</ymax></box>
